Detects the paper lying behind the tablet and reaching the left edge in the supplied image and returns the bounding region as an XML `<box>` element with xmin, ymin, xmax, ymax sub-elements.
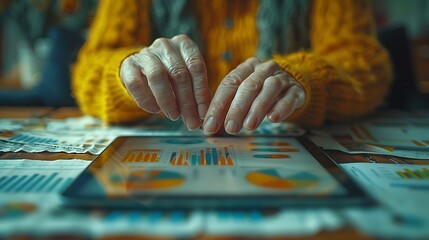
<box><xmin>0</xmin><ymin>115</ymin><xmax>305</xmax><ymax>154</ymax></box>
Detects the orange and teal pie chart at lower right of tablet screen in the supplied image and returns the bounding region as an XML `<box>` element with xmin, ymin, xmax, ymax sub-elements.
<box><xmin>246</xmin><ymin>169</ymin><xmax>319</xmax><ymax>190</ymax></box>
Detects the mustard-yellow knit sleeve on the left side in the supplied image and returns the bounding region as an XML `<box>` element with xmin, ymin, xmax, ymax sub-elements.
<box><xmin>72</xmin><ymin>0</ymin><xmax>150</xmax><ymax>123</ymax></box>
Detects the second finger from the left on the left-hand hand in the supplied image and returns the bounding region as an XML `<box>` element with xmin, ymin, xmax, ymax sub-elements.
<box><xmin>134</xmin><ymin>48</ymin><xmax>180</xmax><ymax>120</ymax></box>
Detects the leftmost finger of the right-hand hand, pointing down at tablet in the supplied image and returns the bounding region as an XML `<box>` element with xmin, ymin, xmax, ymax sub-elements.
<box><xmin>204</xmin><ymin>58</ymin><xmax>260</xmax><ymax>135</ymax></box>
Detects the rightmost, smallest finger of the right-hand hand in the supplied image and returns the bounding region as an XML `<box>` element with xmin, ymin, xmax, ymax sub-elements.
<box><xmin>268</xmin><ymin>85</ymin><xmax>305</xmax><ymax>123</ymax></box>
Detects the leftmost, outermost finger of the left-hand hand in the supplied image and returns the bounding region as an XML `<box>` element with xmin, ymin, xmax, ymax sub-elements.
<box><xmin>120</xmin><ymin>58</ymin><xmax>161</xmax><ymax>113</ymax></box>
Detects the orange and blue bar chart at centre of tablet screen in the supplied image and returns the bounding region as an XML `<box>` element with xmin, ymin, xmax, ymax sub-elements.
<box><xmin>170</xmin><ymin>146</ymin><xmax>235</xmax><ymax>166</ymax></box>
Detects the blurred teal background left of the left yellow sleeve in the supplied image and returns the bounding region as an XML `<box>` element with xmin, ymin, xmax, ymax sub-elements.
<box><xmin>0</xmin><ymin>0</ymin><xmax>97</xmax><ymax>106</ymax></box>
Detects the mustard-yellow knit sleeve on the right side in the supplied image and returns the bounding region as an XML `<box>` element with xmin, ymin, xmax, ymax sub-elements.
<box><xmin>274</xmin><ymin>0</ymin><xmax>392</xmax><ymax>127</ymax></box>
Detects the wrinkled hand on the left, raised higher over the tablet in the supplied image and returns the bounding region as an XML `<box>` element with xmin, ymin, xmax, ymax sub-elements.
<box><xmin>120</xmin><ymin>35</ymin><xmax>210</xmax><ymax>130</ymax></box>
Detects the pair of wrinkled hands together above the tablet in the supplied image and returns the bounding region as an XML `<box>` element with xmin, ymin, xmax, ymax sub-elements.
<box><xmin>120</xmin><ymin>35</ymin><xmax>305</xmax><ymax>135</ymax></box>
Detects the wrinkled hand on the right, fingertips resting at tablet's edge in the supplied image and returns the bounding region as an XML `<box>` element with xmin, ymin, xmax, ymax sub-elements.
<box><xmin>203</xmin><ymin>58</ymin><xmax>305</xmax><ymax>135</ymax></box>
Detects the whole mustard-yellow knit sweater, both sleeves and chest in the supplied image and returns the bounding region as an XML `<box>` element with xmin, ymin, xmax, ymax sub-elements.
<box><xmin>72</xmin><ymin>0</ymin><xmax>391</xmax><ymax>127</ymax></box>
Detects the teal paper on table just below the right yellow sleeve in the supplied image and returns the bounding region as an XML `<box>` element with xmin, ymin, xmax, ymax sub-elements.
<box><xmin>310</xmin><ymin>112</ymin><xmax>429</xmax><ymax>159</ymax></box>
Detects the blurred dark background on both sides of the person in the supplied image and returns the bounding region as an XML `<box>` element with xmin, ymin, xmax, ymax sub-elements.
<box><xmin>0</xmin><ymin>0</ymin><xmax>429</xmax><ymax>109</ymax></box>
